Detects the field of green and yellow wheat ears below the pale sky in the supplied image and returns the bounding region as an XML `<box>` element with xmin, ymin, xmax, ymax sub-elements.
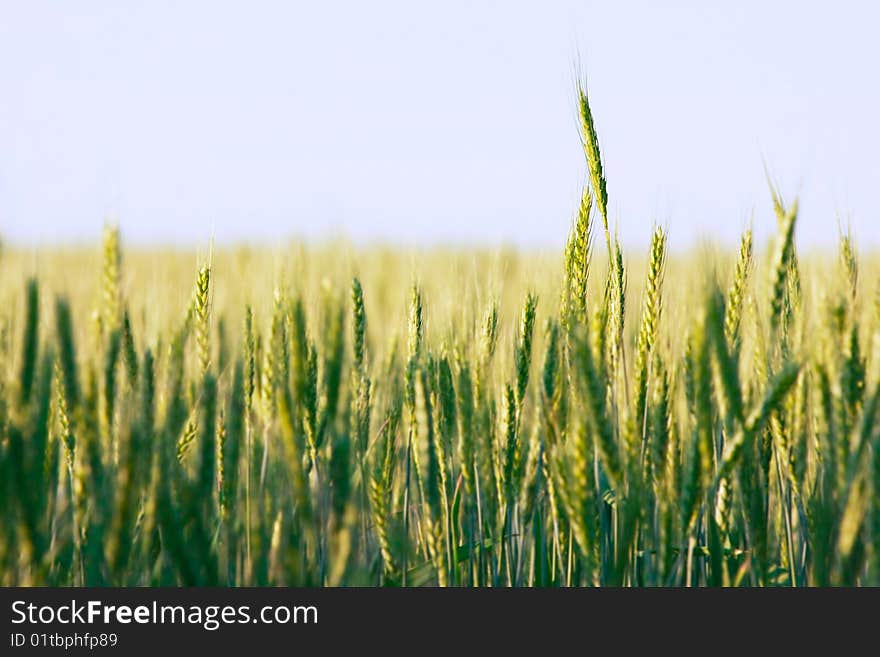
<box><xmin>0</xmin><ymin>90</ymin><xmax>880</xmax><ymax>586</ymax></box>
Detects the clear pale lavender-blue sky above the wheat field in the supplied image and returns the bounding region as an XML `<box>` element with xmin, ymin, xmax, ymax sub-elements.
<box><xmin>0</xmin><ymin>0</ymin><xmax>880</xmax><ymax>247</ymax></box>
